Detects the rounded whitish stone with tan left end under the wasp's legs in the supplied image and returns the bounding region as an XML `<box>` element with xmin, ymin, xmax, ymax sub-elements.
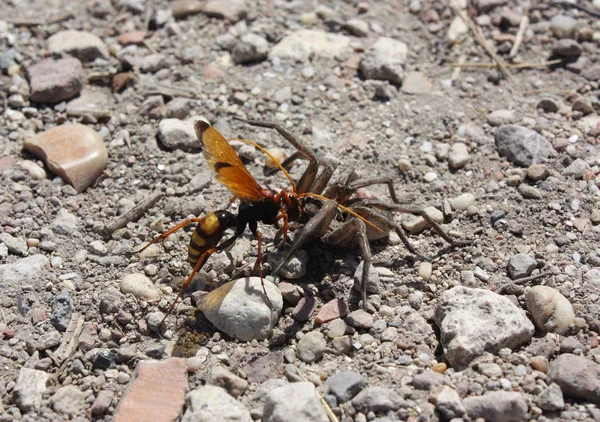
<box><xmin>198</xmin><ymin>277</ymin><xmax>283</xmax><ymax>341</ymax></box>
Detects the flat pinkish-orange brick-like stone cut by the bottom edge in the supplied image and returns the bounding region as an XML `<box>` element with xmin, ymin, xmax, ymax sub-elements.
<box><xmin>113</xmin><ymin>358</ymin><xmax>188</xmax><ymax>422</ymax></box>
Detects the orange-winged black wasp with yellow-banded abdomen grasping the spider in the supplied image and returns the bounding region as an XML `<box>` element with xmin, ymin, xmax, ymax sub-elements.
<box><xmin>140</xmin><ymin>115</ymin><xmax>381</xmax><ymax>318</ymax></box>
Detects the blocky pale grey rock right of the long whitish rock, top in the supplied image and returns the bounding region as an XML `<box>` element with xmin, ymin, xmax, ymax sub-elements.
<box><xmin>359</xmin><ymin>37</ymin><xmax>408</xmax><ymax>84</ymax></box>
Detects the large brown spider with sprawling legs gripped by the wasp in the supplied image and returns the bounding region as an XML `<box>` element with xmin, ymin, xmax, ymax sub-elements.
<box><xmin>234</xmin><ymin>116</ymin><xmax>471</xmax><ymax>309</ymax></box>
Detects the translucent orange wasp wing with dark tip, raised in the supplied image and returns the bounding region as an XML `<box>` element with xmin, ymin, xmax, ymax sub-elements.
<box><xmin>194</xmin><ymin>120</ymin><xmax>265</xmax><ymax>202</ymax></box>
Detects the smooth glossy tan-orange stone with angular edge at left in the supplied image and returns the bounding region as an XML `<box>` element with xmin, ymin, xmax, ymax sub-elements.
<box><xmin>23</xmin><ymin>124</ymin><xmax>108</xmax><ymax>192</ymax></box>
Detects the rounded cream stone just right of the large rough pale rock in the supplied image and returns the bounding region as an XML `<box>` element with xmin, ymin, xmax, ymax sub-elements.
<box><xmin>527</xmin><ymin>286</ymin><xmax>575</xmax><ymax>334</ymax></box>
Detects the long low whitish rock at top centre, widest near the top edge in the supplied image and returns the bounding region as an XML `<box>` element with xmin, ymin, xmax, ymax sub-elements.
<box><xmin>269</xmin><ymin>29</ymin><xmax>351</xmax><ymax>62</ymax></box>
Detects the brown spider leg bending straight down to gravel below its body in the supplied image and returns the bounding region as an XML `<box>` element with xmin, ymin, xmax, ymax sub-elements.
<box><xmin>323</xmin><ymin>218</ymin><xmax>373</xmax><ymax>311</ymax></box>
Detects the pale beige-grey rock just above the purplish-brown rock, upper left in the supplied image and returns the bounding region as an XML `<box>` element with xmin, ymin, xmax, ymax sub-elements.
<box><xmin>48</xmin><ymin>29</ymin><xmax>109</xmax><ymax>62</ymax></box>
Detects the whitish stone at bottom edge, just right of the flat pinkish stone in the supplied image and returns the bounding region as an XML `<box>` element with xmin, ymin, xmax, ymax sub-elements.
<box><xmin>181</xmin><ymin>385</ymin><xmax>252</xmax><ymax>422</ymax></box>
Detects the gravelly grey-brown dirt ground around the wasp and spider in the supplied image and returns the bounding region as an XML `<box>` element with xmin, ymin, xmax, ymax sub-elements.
<box><xmin>0</xmin><ymin>0</ymin><xmax>600</xmax><ymax>421</ymax></box>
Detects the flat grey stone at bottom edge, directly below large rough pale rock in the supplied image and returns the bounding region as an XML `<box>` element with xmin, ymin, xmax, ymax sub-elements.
<box><xmin>463</xmin><ymin>391</ymin><xmax>527</xmax><ymax>422</ymax></box>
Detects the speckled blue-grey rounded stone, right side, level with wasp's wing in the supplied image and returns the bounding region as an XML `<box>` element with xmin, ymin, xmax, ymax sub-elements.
<box><xmin>496</xmin><ymin>125</ymin><xmax>555</xmax><ymax>167</ymax></box>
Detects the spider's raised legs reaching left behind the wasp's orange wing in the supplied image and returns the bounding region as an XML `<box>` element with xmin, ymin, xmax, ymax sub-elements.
<box><xmin>233</xmin><ymin>116</ymin><xmax>333</xmax><ymax>194</ymax></box>
